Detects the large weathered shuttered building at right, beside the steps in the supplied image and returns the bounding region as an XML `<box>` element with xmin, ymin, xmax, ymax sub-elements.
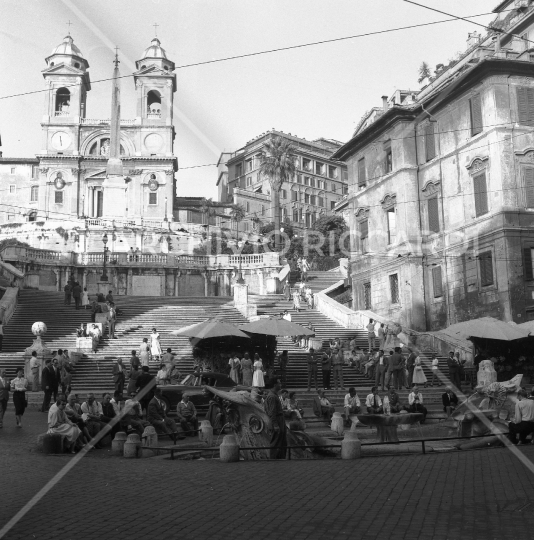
<box><xmin>333</xmin><ymin>0</ymin><xmax>534</xmax><ymax>330</ymax></box>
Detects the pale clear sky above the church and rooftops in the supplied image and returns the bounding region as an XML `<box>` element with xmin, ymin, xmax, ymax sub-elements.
<box><xmin>0</xmin><ymin>0</ymin><xmax>498</xmax><ymax>199</ymax></box>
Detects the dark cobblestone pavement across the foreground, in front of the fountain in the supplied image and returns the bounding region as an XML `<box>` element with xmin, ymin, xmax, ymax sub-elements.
<box><xmin>0</xmin><ymin>413</ymin><xmax>534</xmax><ymax>540</ymax></box>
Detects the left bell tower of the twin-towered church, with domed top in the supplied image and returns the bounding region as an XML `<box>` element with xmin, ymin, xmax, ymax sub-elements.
<box><xmin>42</xmin><ymin>34</ymin><xmax>91</xmax><ymax>155</ymax></box>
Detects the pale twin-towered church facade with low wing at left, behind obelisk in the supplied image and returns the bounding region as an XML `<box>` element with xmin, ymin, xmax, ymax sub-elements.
<box><xmin>0</xmin><ymin>35</ymin><xmax>177</xmax><ymax>225</ymax></box>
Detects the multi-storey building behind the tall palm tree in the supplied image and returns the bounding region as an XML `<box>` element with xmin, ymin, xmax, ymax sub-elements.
<box><xmin>217</xmin><ymin>130</ymin><xmax>348</xmax><ymax>232</ymax></box>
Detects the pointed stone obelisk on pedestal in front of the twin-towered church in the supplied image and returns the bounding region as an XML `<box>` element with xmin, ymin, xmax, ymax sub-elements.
<box><xmin>102</xmin><ymin>49</ymin><xmax>127</xmax><ymax>218</ymax></box>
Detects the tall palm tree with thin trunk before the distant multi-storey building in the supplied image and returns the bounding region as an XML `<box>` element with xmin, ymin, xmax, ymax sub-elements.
<box><xmin>260</xmin><ymin>137</ymin><xmax>297</xmax><ymax>251</ymax></box>
